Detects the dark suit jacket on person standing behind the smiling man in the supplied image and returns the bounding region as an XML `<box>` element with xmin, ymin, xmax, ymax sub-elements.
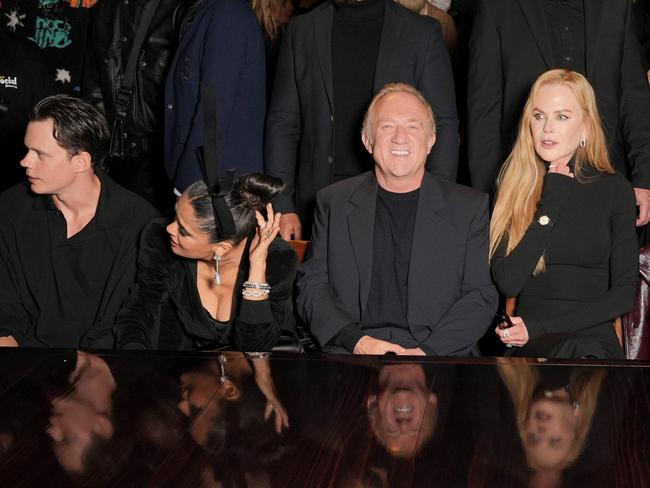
<box><xmin>264</xmin><ymin>0</ymin><xmax>458</xmax><ymax>229</ymax></box>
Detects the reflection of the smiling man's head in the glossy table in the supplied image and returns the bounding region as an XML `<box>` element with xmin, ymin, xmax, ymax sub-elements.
<box><xmin>368</xmin><ymin>364</ymin><xmax>437</xmax><ymax>456</ymax></box>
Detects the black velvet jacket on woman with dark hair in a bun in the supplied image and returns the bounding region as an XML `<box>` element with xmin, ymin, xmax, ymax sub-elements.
<box><xmin>115</xmin><ymin>219</ymin><xmax>298</xmax><ymax>351</ymax></box>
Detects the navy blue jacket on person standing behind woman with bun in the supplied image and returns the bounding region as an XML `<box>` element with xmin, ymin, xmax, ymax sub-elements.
<box><xmin>165</xmin><ymin>0</ymin><xmax>266</xmax><ymax>191</ymax></box>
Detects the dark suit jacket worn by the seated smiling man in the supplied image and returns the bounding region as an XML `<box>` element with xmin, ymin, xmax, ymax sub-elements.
<box><xmin>297</xmin><ymin>173</ymin><xmax>497</xmax><ymax>355</ymax></box>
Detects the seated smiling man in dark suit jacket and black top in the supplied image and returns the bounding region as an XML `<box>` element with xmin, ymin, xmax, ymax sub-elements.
<box><xmin>297</xmin><ymin>83</ymin><xmax>497</xmax><ymax>356</ymax></box>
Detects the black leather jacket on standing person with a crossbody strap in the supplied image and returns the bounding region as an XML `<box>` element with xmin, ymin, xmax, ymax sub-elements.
<box><xmin>81</xmin><ymin>0</ymin><xmax>189</xmax><ymax>144</ymax></box>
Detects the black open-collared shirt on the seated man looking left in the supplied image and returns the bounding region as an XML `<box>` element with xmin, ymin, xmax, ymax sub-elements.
<box><xmin>0</xmin><ymin>175</ymin><xmax>156</xmax><ymax>348</ymax></box>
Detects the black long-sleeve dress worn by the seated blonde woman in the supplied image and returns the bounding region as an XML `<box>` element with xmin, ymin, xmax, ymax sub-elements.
<box><xmin>491</xmin><ymin>167</ymin><xmax>638</xmax><ymax>358</ymax></box>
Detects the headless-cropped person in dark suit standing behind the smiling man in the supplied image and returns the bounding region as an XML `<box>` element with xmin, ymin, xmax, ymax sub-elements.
<box><xmin>264</xmin><ymin>0</ymin><xmax>458</xmax><ymax>239</ymax></box>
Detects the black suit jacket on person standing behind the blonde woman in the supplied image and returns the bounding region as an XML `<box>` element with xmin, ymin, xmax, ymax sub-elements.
<box><xmin>467</xmin><ymin>0</ymin><xmax>650</xmax><ymax>191</ymax></box>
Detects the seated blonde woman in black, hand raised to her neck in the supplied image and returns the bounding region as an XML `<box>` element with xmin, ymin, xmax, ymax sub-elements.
<box><xmin>490</xmin><ymin>69</ymin><xmax>638</xmax><ymax>358</ymax></box>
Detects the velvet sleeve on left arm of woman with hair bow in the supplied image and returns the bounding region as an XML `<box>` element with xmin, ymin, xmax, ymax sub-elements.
<box><xmin>114</xmin><ymin>220</ymin><xmax>172</xmax><ymax>349</ymax></box>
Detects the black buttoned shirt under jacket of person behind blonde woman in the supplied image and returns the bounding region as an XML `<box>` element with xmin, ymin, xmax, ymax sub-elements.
<box><xmin>542</xmin><ymin>0</ymin><xmax>586</xmax><ymax>75</ymax></box>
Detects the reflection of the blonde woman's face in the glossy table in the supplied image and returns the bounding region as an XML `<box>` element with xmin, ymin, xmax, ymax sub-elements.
<box><xmin>525</xmin><ymin>390</ymin><xmax>579</xmax><ymax>469</ymax></box>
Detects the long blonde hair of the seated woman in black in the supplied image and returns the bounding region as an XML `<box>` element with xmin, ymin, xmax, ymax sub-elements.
<box><xmin>490</xmin><ymin>69</ymin><xmax>614</xmax><ymax>274</ymax></box>
